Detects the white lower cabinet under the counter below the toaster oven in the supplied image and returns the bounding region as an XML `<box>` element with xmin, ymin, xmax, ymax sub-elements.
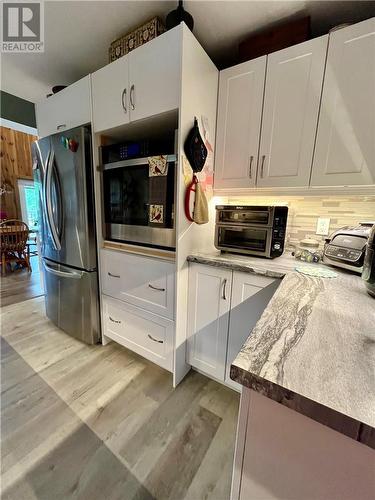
<box><xmin>187</xmin><ymin>263</ymin><xmax>280</xmax><ymax>390</ymax></box>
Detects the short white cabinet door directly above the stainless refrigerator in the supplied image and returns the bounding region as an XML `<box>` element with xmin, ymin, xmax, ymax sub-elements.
<box><xmin>35</xmin><ymin>76</ymin><xmax>91</xmax><ymax>137</ymax></box>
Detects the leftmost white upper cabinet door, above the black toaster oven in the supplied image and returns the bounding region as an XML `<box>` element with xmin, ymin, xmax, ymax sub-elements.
<box><xmin>215</xmin><ymin>56</ymin><xmax>266</xmax><ymax>189</ymax></box>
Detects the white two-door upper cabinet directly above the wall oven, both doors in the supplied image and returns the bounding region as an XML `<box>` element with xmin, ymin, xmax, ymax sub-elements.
<box><xmin>92</xmin><ymin>26</ymin><xmax>182</xmax><ymax>132</ymax></box>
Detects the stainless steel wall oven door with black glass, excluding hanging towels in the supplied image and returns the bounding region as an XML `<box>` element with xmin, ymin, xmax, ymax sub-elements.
<box><xmin>103</xmin><ymin>155</ymin><xmax>176</xmax><ymax>249</ymax></box>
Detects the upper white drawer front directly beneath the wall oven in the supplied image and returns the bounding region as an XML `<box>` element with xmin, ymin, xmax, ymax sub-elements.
<box><xmin>101</xmin><ymin>250</ymin><xmax>175</xmax><ymax>319</ymax></box>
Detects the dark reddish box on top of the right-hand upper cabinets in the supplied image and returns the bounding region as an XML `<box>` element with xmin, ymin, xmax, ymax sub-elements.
<box><xmin>238</xmin><ymin>16</ymin><xmax>311</xmax><ymax>62</ymax></box>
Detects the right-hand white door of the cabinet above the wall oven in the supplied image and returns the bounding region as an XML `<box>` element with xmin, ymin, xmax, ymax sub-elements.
<box><xmin>129</xmin><ymin>26</ymin><xmax>182</xmax><ymax>121</ymax></box>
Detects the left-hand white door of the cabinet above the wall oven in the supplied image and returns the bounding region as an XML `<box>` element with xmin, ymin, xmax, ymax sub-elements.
<box><xmin>92</xmin><ymin>56</ymin><xmax>130</xmax><ymax>132</ymax></box>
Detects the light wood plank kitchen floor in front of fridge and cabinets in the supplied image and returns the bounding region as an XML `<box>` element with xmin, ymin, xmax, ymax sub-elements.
<box><xmin>1</xmin><ymin>297</ymin><xmax>239</xmax><ymax>500</ymax></box>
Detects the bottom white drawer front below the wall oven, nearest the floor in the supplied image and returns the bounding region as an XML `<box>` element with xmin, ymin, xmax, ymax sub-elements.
<box><xmin>102</xmin><ymin>296</ymin><xmax>174</xmax><ymax>371</ymax></box>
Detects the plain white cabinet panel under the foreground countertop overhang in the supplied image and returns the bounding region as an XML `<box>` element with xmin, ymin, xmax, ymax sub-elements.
<box><xmin>230</xmin><ymin>387</ymin><xmax>375</xmax><ymax>500</ymax></box>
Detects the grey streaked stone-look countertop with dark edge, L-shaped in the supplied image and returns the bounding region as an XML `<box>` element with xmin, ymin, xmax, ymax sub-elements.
<box><xmin>188</xmin><ymin>254</ymin><xmax>375</xmax><ymax>449</ymax></box>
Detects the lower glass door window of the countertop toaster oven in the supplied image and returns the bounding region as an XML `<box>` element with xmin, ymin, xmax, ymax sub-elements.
<box><xmin>219</xmin><ymin>227</ymin><xmax>268</xmax><ymax>252</ymax></box>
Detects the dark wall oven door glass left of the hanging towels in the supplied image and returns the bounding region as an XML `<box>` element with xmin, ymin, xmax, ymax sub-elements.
<box><xmin>103</xmin><ymin>164</ymin><xmax>149</xmax><ymax>226</ymax></box>
